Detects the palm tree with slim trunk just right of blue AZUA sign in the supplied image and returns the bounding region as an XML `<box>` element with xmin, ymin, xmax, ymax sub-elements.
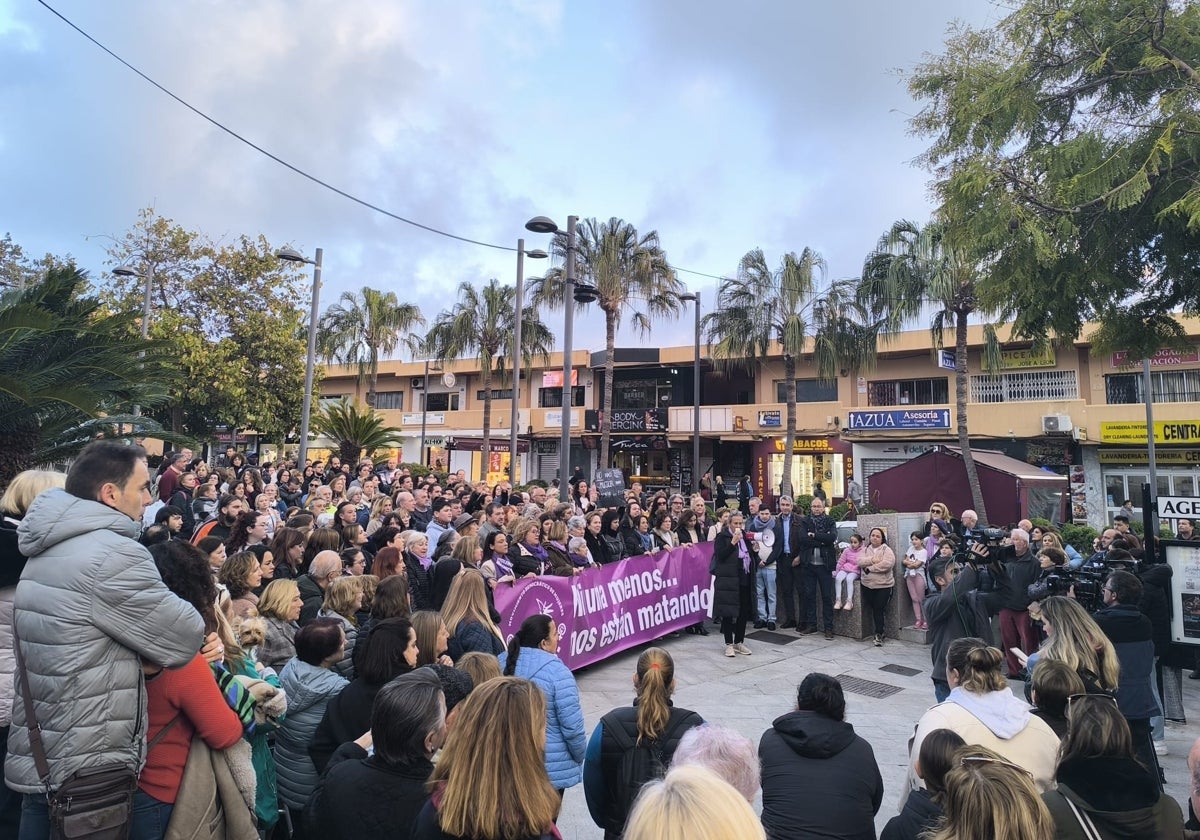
<box><xmin>859</xmin><ymin>220</ymin><xmax>1000</xmax><ymax>522</ymax></box>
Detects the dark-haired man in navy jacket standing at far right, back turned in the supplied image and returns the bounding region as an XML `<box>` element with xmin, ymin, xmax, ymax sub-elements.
<box><xmin>1093</xmin><ymin>571</ymin><xmax>1162</xmax><ymax>784</ymax></box>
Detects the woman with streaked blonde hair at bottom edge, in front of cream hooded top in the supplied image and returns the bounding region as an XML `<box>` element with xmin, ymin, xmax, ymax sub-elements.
<box><xmin>926</xmin><ymin>744</ymin><xmax>1057</xmax><ymax>840</ymax></box>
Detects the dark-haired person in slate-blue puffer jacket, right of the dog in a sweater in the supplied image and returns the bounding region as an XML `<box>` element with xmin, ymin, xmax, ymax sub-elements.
<box><xmin>275</xmin><ymin>617</ymin><xmax>349</xmax><ymax>824</ymax></box>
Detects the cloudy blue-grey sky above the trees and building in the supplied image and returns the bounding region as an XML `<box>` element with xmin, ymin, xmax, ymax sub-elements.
<box><xmin>0</xmin><ymin>0</ymin><xmax>1003</xmax><ymax>349</ymax></box>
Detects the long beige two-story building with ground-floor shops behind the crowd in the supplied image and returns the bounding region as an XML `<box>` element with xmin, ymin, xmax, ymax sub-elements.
<box><xmin>318</xmin><ymin>319</ymin><xmax>1200</xmax><ymax>526</ymax></box>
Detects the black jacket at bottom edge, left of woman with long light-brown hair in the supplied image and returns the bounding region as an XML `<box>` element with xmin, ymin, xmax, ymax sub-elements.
<box><xmin>304</xmin><ymin>733</ymin><xmax>433</xmax><ymax>840</ymax></box>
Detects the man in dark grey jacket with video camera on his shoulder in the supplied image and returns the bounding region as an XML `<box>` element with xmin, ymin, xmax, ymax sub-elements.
<box><xmin>922</xmin><ymin>554</ymin><xmax>991</xmax><ymax>703</ymax></box>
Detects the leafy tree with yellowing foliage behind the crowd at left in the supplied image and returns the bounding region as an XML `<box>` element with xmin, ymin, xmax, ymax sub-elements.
<box><xmin>102</xmin><ymin>210</ymin><xmax>308</xmax><ymax>440</ymax></box>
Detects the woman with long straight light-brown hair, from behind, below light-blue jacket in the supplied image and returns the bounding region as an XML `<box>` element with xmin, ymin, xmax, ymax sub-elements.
<box><xmin>413</xmin><ymin>677</ymin><xmax>562</xmax><ymax>840</ymax></box>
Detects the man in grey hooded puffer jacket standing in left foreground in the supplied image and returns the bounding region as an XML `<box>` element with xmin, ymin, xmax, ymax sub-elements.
<box><xmin>5</xmin><ymin>440</ymin><xmax>204</xmax><ymax>816</ymax></box>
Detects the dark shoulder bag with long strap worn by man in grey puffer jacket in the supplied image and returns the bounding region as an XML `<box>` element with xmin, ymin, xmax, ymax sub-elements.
<box><xmin>12</xmin><ymin>616</ymin><xmax>147</xmax><ymax>840</ymax></box>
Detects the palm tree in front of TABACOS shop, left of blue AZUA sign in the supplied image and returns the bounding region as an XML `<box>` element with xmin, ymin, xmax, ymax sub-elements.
<box><xmin>702</xmin><ymin>248</ymin><xmax>877</xmax><ymax>496</ymax></box>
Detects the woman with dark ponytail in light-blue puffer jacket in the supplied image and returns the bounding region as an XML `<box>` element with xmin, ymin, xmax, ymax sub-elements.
<box><xmin>500</xmin><ymin>614</ymin><xmax>587</xmax><ymax>791</ymax></box>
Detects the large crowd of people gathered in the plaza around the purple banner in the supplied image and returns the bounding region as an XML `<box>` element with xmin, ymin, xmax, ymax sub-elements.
<box><xmin>0</xmin><ymin>442</ymin><xmax>1196</xmax><ymax>840</ymax></box>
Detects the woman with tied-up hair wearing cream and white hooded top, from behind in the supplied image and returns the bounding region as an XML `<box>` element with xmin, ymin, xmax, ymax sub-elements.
<box><xmin>900</xmin><ymin>637</ymin><xmax>1058</xmax><ymax>808</ymax></box>
